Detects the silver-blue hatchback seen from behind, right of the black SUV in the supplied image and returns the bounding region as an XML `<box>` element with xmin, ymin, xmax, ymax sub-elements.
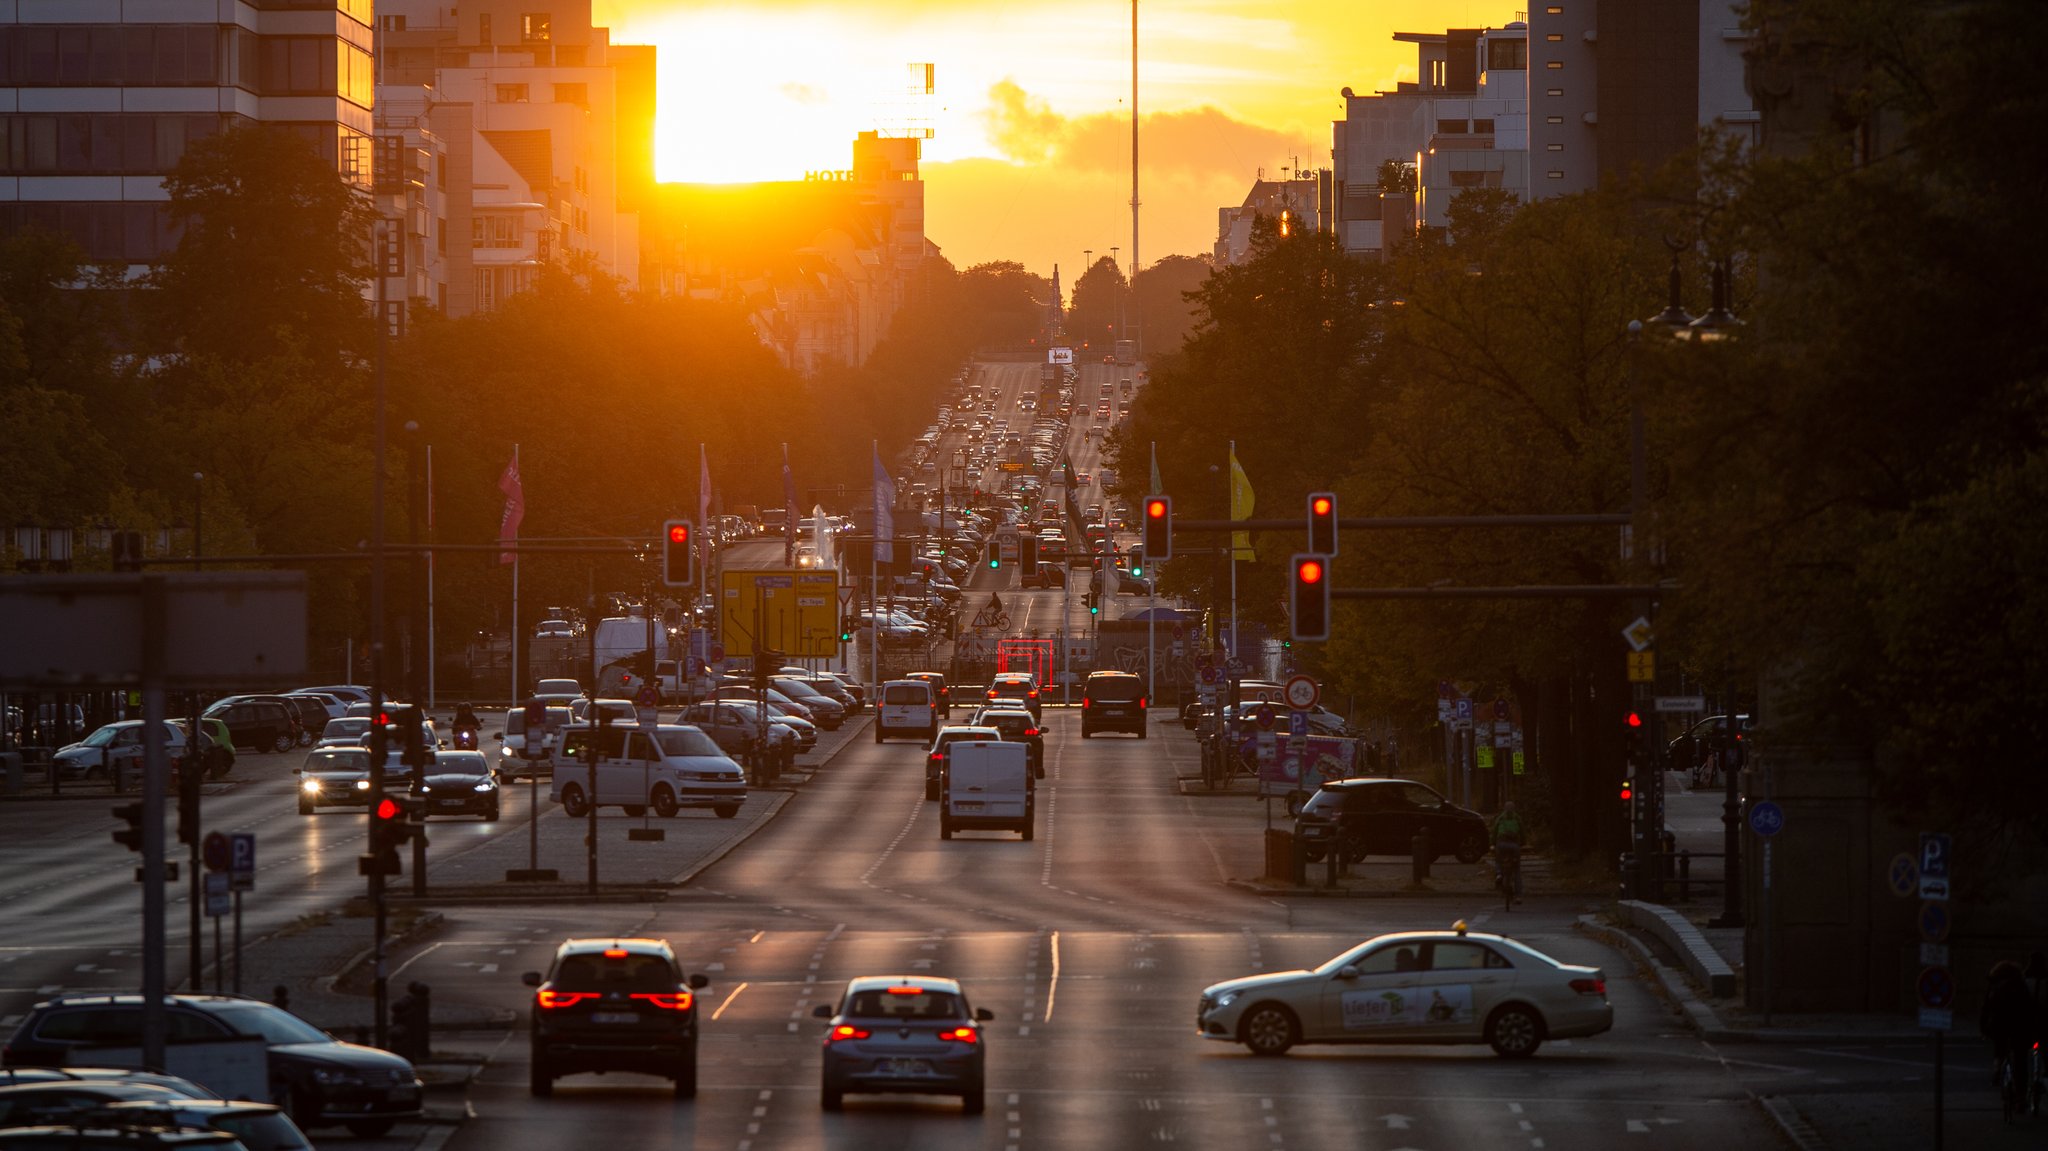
<box><xmin>811</xmin><ymin>975</ymin><xmax>995</xmax><ymax>1114</ymax></box>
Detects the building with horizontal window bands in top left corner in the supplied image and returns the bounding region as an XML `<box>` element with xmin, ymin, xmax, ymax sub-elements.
<box><xmin>0</xmin><ymin>0</ymin><xmax>375</xmax><ymax>272</ymax></box>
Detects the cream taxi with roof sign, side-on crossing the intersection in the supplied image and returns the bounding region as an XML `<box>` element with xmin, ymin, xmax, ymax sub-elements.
<box><xmin>1196</xmin><ymin>922</ymin><xmax>1614</xmax><ymax>1059</ymax></box>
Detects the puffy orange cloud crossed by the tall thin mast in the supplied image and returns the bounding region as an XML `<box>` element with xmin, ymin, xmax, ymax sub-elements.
<box><xmin>981</xmin><ymin>80</ymin><xmax>1329</xmax><ymax>180</ymax></box>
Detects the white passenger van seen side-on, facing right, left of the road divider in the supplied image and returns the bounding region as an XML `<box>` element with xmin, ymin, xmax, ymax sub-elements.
<box><xmin>547</xmin><ymin>723</ymin><xmax>748</xmax><ymax>819</ymax></box>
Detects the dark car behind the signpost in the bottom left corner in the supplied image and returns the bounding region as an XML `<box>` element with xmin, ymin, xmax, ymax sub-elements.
<box><xmin>0</xmin><ymin>995</ymin><xmax>420</xmax><ymax>1139</ymax></box>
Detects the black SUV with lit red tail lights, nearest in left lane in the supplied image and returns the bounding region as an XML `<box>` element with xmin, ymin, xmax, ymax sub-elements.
<box><xmin>526</xmin><ymin>938</ymin><xmax>711</xmax><ymax>1100</ymax></box>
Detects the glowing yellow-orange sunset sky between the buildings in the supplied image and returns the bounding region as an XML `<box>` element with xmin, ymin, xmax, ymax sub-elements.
<box><xmin>592</xmin><ymin>0</ymin><xmax>1518</xmax><ymax>276</ymax></box>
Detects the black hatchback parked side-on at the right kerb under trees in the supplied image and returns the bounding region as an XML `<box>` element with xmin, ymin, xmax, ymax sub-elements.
<box><xmin>1294</xmin><ymin>778</ymin><xmax>1491</xmax><ymax>862</ymax></box>
